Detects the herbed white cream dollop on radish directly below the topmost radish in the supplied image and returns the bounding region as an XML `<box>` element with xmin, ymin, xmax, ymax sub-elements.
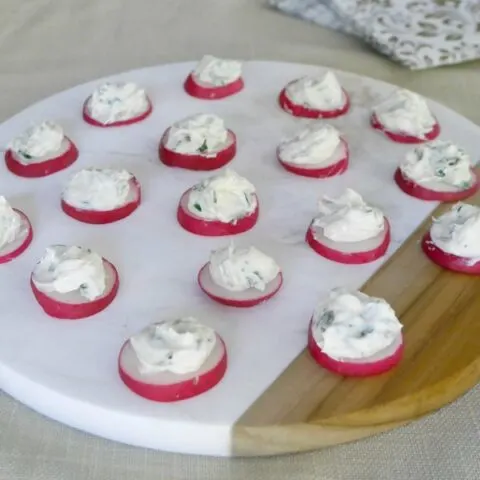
<box><xmin>165</xmin><ymin>113</ymin><xmax>229</xmax><ymax>157</ymax></box>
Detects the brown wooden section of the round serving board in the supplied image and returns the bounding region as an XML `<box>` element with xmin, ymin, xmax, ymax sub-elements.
<box><xmin>232</xmin><ymin>193</ymin><xmax>480</xmax><ymax>456</ymax></box>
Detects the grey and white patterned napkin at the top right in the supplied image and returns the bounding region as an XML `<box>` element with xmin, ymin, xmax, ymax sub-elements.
<box><xmin>269</xmin><ymin>0</ymin><xmax>480</xmax><ymax>70</ymax></box>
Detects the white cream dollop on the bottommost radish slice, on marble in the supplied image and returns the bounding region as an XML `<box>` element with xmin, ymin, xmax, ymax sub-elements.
<box><xmin>130</xmin><ymin>317</ymin><xmax>217</xmax><ymax>375</ymax></box>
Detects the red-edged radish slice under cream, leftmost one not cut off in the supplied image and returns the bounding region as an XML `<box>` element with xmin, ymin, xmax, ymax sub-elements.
<box><xmin>5</xmin><ymin>137</ymin><xmax>78</xmax><ymax>178</ymax></box>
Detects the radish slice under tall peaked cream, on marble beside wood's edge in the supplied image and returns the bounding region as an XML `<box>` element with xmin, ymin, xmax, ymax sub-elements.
<box><xmin>306</xmin><ymin>217</ymin><xmax>390</xmax><ymax>265</ymax></box>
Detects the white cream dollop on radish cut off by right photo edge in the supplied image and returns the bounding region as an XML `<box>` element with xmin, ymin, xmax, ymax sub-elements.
<box><xmin>430</xmin><ymin>202</ymin><xmax>480</xmax><ymax>264</ymax></box>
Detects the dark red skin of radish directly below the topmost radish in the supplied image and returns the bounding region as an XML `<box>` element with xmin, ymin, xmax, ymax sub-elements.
<box><xmin>158</xmin><ymin>129</ymin><xmax>237</xmax><ymax>171</ymax></box>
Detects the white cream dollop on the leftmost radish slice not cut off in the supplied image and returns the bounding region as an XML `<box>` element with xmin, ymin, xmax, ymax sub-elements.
<box><xmin>9</xmin><ymin>121</ymin><xmax>65</xmax><ymax>165</ymax></box>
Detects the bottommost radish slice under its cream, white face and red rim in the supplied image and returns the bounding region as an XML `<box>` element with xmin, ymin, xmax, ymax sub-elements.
<box><xmin>118</xmin><ymin>334</ymin><xmax>227</xmax><ymax>402</ymax></box>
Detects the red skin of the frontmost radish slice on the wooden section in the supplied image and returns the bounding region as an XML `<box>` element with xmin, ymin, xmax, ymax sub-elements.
<box><xmin>308</xmin><ymin>324</ymin><xmax>404</xmax><ymax>377</ymax></box>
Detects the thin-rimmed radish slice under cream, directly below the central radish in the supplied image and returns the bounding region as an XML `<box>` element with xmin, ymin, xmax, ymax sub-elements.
<box><xmin>198</xmin><ymin>263</ymin><xmax>283</xmax><ymax>308</ymax></box>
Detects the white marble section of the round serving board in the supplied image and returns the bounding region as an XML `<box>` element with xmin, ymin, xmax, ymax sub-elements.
<box><xmin>0</xmin><ymin>62</ymin><xmax>480</xmax><ymax>455</ymax></box>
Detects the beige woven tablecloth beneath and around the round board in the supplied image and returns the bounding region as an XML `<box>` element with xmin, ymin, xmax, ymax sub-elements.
<box><xmin>0</xmin><ymin>0</ymin><xmax>480</xmax><ymax>480</ymax></box>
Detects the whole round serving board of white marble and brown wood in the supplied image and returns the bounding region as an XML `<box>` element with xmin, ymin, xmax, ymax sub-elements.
<box><xmin>0</xmin><ymin>62</ymin><xmax>480</xmax><ymax>455</ymax></box>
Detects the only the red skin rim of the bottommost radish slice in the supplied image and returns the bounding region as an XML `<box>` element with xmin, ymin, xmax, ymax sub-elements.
<box><xmin>118</xmin><ymin>334</ymin><xmax>228</xmax><ymax>403</ymax></box>
